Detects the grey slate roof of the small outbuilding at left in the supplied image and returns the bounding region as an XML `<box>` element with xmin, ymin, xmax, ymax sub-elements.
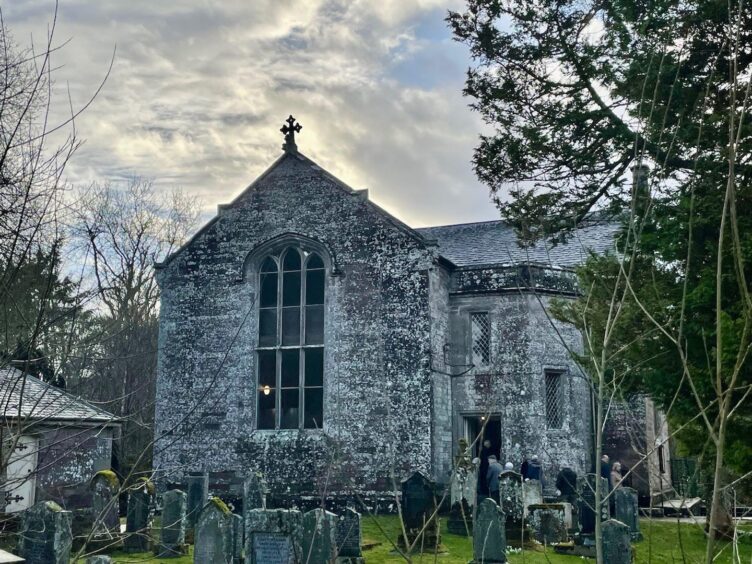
<box><xmin>0</xmin><ymin>368</ymin><xmax>117</xmax><ymax>423</ymax></box>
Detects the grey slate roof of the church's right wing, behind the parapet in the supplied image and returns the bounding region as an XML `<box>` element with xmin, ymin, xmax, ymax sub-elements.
<box><xmin>416</xmin><ymin>221</ymin><xmax>618</xmax><ymax>268</ymax></box>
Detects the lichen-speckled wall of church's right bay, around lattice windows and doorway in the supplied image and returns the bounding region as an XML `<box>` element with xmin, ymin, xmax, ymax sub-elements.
<box><xmin>450</xmin><ymin>285</ymin><xmax>592</xmax><ymax>491</ymax></box>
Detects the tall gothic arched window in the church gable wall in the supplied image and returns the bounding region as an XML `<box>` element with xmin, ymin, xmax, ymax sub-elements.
<box><xmin>256</xmin><ymin>247</ymin><xmax>325</xmax><ymax>429</ymax></box>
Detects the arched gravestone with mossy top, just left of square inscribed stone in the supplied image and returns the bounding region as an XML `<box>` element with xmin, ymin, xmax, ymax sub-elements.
<box><xmin>193</xmin><ymin>497</ymin><xmax>233</xmax><ymax>564</ymax></box>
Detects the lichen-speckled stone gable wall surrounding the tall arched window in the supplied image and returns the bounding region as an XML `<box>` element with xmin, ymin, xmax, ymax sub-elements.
<box><xmin>154</xmin><ymin>154</ymin><xmax>441</xmax><ymax>497</ymax></box>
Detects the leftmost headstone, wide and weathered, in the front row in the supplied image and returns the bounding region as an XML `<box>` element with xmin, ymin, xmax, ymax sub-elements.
<box><xmin>18</xmin><ymin>501</ymin><xmax>73</xmax><ymax>564</ymax></box>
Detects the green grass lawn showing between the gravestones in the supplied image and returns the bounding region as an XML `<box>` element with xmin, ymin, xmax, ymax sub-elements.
<box><xmin>94</xmin><ymin>516</ymin><xmax>752</xmax><ymax>564</ymax></box>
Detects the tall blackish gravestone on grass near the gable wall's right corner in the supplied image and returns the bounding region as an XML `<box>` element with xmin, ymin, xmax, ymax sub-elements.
<box><xmin>398</xmin><ymin>472</ymin><xmax>441</xmax><ymax>551</ymax></box>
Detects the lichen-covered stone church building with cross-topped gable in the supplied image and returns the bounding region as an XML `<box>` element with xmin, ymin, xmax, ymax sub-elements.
<box><xmin>154</xmin><ymin>120</ymin><xmax>664</xmax><ymax>506</ymax></box>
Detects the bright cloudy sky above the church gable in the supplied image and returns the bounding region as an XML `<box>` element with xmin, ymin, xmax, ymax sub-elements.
<box><xmin>0</xmin><ymin>0</ymin><xmax>498</xmax><ymax>227</ymax></box>
